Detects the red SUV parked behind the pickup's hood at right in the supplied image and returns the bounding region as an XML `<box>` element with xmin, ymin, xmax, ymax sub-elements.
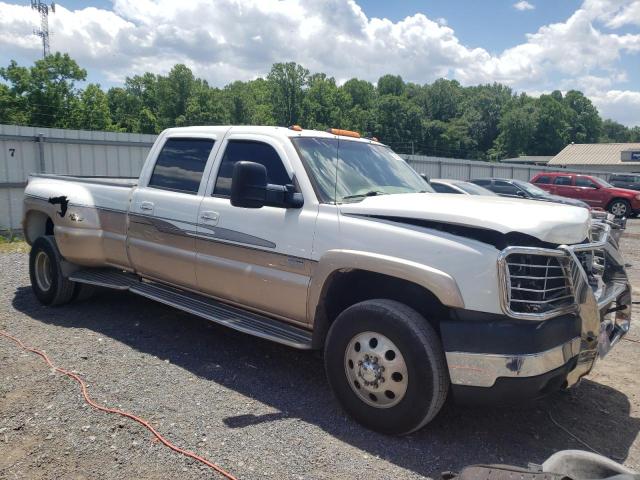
<box><xmin>531</xmin><ymin>172</ymin><xmax>640</xmax><ymax>217</ymax></box>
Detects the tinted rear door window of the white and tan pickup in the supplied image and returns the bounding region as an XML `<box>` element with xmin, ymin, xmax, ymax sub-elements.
<box><xmin>148</xmin><ymin>138</ymin><xmax>214</xmax><ymax>194</ymax></box>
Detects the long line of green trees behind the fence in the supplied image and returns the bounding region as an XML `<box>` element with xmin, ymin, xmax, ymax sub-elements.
<box><xmin>0</xmin><ymin>53</ymin><xmax>640</xmax><ymax>159</ymax></box>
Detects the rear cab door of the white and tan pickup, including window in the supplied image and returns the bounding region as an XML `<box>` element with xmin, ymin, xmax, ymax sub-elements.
<box><xmin>127</xmin><ymin>137</ymin><xmax>222</xmax><ymax>288</ymax></box>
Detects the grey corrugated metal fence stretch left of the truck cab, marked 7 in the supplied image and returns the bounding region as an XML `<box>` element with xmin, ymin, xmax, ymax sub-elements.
<box><xmin>0</xmin><ymin>125</ymin><xmax>156</xmax><ymax>230</ymax></box>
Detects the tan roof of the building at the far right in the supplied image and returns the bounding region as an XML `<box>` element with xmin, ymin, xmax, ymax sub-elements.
<box><xmin>549</xmin><ymin>143</ymin><xmax>640</xmax><ymax>165</ymax></box>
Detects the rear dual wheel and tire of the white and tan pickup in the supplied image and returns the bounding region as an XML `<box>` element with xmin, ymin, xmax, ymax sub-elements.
<box><xmin>29</xmin><ymin>236</ymin><xmax>76</xmax><ymax>306</ymax></box>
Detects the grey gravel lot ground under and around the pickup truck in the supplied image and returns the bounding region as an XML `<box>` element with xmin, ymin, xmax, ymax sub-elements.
<box><xmin>0</xmin><ymin>220</ymin><xmax>640</xmax><ymax>479</ymax></box>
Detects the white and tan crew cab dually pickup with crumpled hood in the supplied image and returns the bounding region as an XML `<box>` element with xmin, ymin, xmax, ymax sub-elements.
<box><xmin>23</xmin><ymin>126</ymin><xmax>631</xmax><ymax>434</ymax></box>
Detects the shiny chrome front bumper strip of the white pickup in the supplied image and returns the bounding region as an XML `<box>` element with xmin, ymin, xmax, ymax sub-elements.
<box><xmin>445</xmin><ymin>337</ymin><xmax>581</xmax><ymax>387</ymax></box>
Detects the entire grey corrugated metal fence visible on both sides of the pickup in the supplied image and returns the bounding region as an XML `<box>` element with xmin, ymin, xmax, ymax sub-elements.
<box><xmin>0</xmin><ymin>125</ymin><xmax>608</xmax><ymax>230</ymax></box>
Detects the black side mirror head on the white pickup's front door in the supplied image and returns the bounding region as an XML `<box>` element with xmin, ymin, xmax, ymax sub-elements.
<box><xmin>231</xmin><ymin>162</ymin><xmax>267</xmax><ymax>208</ymax></box>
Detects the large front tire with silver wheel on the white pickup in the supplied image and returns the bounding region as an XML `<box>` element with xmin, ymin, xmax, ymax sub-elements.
<box><xmin>324</xmin><ymin>299</ymin><xmax>449</xmax><ymax>435</ymax></box>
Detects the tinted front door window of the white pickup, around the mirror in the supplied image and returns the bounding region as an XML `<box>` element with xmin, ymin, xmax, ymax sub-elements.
<box><xmin>213</xmin><ymin>140</ymin><xmax>291</xmax><ymax>197</ymax></box>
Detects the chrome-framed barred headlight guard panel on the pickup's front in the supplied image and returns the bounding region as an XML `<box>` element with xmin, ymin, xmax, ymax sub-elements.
<box><xmin>505</xmin><ymin>253</ymin><xmax>575</xmax><ymax>316</ymax></box>
